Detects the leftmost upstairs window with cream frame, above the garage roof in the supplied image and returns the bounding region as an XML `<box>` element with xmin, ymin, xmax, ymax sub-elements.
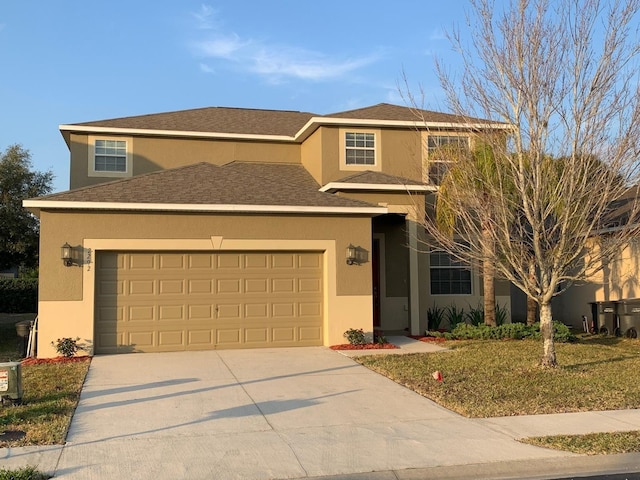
<box><xmin>88</xmin><ymin>136</ymin><xmax>132</xmax><ymax>177</ymax></box>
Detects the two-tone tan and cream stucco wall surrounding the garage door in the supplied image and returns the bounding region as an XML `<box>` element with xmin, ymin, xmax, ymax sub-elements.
<box><xmin>38</xmin><ymin>211</ymin><xmax>372</xmax><ymax>357</ymax></box>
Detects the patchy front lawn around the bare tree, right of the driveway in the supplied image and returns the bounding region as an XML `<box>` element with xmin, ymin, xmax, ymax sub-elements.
<box><xmin>356</xmin><ymin>336</ymin><xmax>640</xmax><ymax>417</ymax></box>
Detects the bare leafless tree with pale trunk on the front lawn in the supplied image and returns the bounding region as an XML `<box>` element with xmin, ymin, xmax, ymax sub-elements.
<box><xmin>425</xmin><ymin>0</ymin><xmax>640</xmax><ymax>366</ymax></box>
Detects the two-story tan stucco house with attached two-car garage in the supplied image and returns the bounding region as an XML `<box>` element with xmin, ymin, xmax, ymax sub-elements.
<box><xmin>24</xmin><ymin>104</ymin><xmax>509</xmax><ymax>357</ymax></box>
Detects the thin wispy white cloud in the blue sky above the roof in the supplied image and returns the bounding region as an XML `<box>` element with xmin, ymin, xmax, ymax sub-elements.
<box><xmin>192</xmin><ymin>5</ymin><xmax>379</xmax><ymax>82</ymax></box>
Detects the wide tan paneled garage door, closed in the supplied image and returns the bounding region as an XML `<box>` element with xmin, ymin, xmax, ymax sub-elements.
<box><xmin>94</xmin><ymin>251</ymin><xmax>323</xmax><ymax>353</ymax></box>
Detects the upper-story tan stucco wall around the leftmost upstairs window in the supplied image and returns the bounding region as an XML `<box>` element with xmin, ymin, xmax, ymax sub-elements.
<box><xmin>70</xmin><ymin>134</ymin><xmax>300</xmax><ymax>189</ymax></box>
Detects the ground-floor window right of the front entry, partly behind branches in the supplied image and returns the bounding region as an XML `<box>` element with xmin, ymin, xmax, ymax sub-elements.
<box><xmin>429</xmin><ymin>250</ymin><xmax>471</xmax><ymax>295</ymax></box>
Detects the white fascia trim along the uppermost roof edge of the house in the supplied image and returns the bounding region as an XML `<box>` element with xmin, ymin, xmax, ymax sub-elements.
<box><xmin>58</xmin><ymin>117</ymin><xmax>514</xmax><ymax>142</ymax></box>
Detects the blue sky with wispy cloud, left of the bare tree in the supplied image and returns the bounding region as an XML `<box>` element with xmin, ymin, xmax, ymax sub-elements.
<box><xmin>0</xmin><ymin>0</ymin><xmax>467</xmax><ymax>191</ymax></box>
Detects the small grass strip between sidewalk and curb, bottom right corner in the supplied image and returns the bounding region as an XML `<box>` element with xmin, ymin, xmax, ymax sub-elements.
<box><xmin>520</xmin><ymin>431</ymin><xmax>640</xmax><ymax>455</ymax></box>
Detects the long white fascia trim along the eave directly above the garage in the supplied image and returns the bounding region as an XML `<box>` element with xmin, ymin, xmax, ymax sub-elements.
<box><xmin>22</xmin><ymin>200</ymin><xmax>387</xmax><ymax>215</ymax></box>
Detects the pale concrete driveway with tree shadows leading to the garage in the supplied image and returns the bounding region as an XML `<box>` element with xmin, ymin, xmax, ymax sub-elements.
<box><xmin>45</xmin><ymin>347</ymin><xmax>567</xmax><ymax>480</ymax></box>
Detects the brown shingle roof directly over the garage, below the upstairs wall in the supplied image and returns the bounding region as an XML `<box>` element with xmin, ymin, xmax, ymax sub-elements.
<box><xmin>37</xmin><ymin>162</ymin><xmax>375</xmax><ymax>208</ymax></box>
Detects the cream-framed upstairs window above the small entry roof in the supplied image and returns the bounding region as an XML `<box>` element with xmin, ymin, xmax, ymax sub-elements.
<box><xmin>340</xmin><ymin>129</ymin><xmax>380</xmax><ymax>170</ymax></box>
